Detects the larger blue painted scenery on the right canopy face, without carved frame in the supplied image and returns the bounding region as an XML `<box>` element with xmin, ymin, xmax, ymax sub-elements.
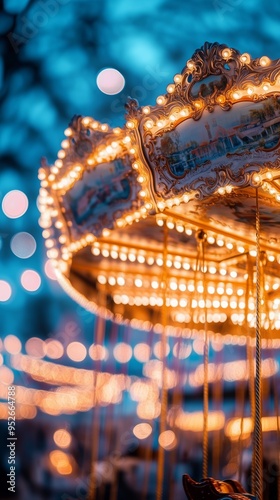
<box><xmin>156</xmin><ymin>97</ymin><xmax>280</xmax><ymax>177</ymax></box>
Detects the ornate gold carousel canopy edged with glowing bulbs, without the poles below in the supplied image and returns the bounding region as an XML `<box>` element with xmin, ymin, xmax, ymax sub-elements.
<box><xmin>39</xmin><ymin>43</ymin><xmax>280</xmax><ymax>337</ymax></box>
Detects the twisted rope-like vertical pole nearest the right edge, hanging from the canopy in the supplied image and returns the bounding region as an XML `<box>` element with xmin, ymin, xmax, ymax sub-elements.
<box><xmin>254</xmin><ymin>188</ymin><xmax>263</xmax><ymax>500</ymax></box>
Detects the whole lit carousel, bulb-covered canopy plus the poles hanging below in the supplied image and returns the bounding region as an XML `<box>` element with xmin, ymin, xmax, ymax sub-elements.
<box><xmin>39</xmin><ymin>43</ymin><xmax>280</xmax><ymax>500</ymax></box>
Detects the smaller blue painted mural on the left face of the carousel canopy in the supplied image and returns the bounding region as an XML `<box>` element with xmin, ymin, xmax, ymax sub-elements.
<box><xmin>65</xmin><ymin>160</ymin><xmax>139</xmax><ymax>233</ymax></box>
